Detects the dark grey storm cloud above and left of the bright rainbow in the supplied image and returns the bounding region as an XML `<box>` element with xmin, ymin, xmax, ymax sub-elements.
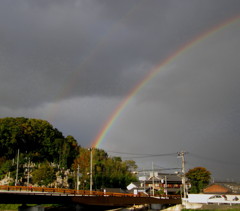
<box><xmin>0</xmin><ymin>0</ymin><xmax>239</xmax><ymax>107</ymax></box>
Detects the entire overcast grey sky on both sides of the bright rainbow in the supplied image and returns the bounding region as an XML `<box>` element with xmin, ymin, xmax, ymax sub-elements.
<box><xmin>0</xmin><ymin>0</ymin><xmax>240</xmax><ymax>181</ymax></box>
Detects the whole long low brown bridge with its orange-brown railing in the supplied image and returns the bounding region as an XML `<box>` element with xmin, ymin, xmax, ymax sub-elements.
<box><xmin>0</xmin><ymin>186</ymin><xmax>181</xmax><ymax>207</ymax></box>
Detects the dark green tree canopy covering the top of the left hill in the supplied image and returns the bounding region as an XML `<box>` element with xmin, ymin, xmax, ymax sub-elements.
<box><xmin>0</xmin><ymin>117</ymin><xmax>78</xmax><ymax>168</ymax></box>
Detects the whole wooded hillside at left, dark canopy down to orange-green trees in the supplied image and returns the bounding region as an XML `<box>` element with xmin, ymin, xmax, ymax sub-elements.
<box><xmin>0</xmin><ymin>117</ymin><xmax>137</xmax><ymax>189</ymax></box>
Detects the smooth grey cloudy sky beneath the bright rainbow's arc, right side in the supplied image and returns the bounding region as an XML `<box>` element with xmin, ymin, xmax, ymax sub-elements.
<box><xmin>103</xmin><ymin>22</ymin><xmax>240</xmax><ymax>181</ymax></box>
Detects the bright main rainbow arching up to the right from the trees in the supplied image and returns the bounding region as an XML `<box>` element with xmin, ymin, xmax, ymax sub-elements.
<box><xmin>92</xmin><ymin>15</ymin><xmax>240</xmax><ymax>148</ymax></box>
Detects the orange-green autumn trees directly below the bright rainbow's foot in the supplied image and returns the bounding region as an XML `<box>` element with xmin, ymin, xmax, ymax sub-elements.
<box><xmin>73</xmin><ymin>148</ymin><xmax>137</xmax><ymax>189</ymax></box>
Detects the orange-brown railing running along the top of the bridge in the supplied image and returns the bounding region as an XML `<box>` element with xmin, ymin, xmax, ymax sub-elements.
<box><xmin>0</xmin><ymin>185</ymin><xmax>180</xmax><ymax>199</ymax></box>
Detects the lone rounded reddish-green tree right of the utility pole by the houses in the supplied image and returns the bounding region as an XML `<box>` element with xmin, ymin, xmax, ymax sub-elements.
<box><xmin>186</xmin><ymin>167</ymin><xmax>211</xmax><ymax>193</ymax></box>
